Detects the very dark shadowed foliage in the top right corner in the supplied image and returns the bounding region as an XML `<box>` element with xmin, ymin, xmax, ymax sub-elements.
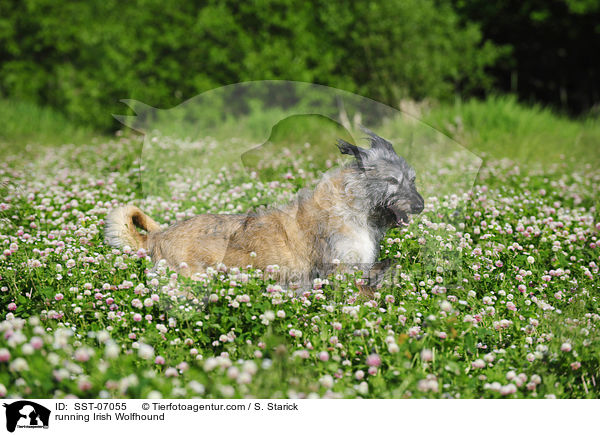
<box><xmin>452</xmin><ymin>0</ymin><xmax>600</xmax><ymax>114</ymax></box>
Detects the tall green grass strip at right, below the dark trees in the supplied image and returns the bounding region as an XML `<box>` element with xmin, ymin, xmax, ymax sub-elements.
<box><xmin>422</xmin><ymin>96</ymin><xmax>600</xmax><ymax>165</ymax></box>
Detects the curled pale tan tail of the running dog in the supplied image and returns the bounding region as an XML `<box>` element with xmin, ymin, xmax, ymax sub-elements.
<box><xmin>104</xmin><ymin>205</ymin><xmax>160</xmax><ymax>249</ymax></box>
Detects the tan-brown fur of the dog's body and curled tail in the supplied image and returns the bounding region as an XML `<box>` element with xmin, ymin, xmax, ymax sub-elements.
<box><xmin>106</xmin><ymin>168</ymin><xmax>352</xmax><ymax>281</ymax></box>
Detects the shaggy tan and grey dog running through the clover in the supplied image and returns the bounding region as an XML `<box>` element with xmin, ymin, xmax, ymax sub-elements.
<box><xmin>105</xmin><ymin>130</ymin><xmax>424</xmax><ymax>288</ymax></box>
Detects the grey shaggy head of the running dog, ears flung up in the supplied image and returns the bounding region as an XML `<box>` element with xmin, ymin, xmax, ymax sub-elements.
<box><xmin>337</xmin><ymin>129</ymin><xmax>424</xmax><ymax>226</ymax></box>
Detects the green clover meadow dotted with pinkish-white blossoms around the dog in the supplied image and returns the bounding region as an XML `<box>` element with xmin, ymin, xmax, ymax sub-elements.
<box><xmin>0</xmin><ymin>134</ymin><xmax>600</xmax><ymax>398</ymax></box>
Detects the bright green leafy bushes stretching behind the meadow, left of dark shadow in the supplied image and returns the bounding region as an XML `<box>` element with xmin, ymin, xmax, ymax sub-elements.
<box><xmin>0</xmin><ymin>0</ymin><xmax>499</xmax><ymax>128</ymax></box>
